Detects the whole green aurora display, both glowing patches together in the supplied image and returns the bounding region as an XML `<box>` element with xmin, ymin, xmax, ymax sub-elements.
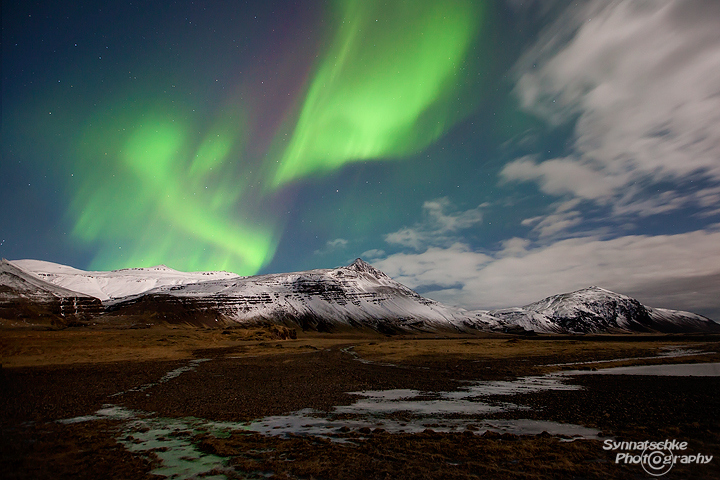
<box><xmin>70</xmin><ymin>0</ymin><xmax>483</xmax><ymax>275</ymax></box>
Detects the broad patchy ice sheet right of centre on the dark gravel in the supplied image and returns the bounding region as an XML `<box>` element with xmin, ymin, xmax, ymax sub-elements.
<box><xmin>253</xmin><ymin>376</ymin><xmax>598</xmax><ymax>442</ymax></box>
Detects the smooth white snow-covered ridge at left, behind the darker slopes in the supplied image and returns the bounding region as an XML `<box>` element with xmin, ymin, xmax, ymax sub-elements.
<box><xmin>10</xmin><ymin>260</ymin><xmax>240</xmax><ymax>302</ymax></box>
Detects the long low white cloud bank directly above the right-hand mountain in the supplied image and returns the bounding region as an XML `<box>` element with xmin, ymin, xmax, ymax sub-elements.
<box><xmin>374</xmin><ymin>230</ymin><xmax>720</xmax><ymax>320</ymax></box>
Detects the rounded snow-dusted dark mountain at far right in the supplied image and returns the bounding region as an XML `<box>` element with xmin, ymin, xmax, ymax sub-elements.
<box><xmin>488</xmin><ymin>286</ymin><xmax>720</xmax><ymax>333</ymax></box>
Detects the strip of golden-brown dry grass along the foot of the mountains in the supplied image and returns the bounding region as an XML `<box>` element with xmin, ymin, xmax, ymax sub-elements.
<box><xmin>0</xmin><ymin>326</ymin><xmax>720</xmax><ymax>373</ymax></box>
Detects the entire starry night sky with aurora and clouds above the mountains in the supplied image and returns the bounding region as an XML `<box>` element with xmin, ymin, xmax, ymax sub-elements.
<box><xmin>0</xmin><ymin>0</ymin><xmax>720</xmax><ymax>320</ymax></box>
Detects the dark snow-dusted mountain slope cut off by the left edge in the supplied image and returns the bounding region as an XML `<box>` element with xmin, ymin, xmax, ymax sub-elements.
<box><xmin>0</xmin><ymin>259</ymin><xmax>103</xmax><ymax>325</ymax></box>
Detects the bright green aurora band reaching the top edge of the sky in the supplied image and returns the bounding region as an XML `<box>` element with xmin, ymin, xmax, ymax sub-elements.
<box><xmin>272</xmin><ymin>0</ymin><xmax>482</xmax><ymax>187</ymax></box>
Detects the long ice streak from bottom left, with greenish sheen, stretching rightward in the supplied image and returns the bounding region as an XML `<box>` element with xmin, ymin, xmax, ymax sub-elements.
<box><xmin>60</xmin><ymin>405</ymin><xmax>599</xmax><ymax>480</ymax></box>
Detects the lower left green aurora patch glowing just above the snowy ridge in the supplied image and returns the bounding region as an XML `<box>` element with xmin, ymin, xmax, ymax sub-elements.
<box><xmin>72</xmin><ymin>103</ymin><xmax>278</xmax><ymax>274</ymax></box>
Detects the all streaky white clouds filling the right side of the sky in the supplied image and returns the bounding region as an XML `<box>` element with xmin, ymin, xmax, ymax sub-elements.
<box><xmin>374</xmin><ymin>0</ymin><xmax>720</xmax><ymax>320</ymax></box>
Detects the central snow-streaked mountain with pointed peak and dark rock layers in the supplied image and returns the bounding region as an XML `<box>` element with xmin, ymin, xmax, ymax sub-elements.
<box><xmin>109</xmin><ymin>259</ymin><xmax>500</xmax><ymax>332</ymax></box>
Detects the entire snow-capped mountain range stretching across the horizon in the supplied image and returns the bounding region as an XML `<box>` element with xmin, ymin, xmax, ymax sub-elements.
<box><xmin>0</xmin><ymin>259</ymin><xmax>720</xmax><ymax>333</ymax></box>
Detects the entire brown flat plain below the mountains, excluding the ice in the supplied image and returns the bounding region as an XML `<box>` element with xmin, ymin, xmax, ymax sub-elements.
<box><xmin>0</xmin><ymin>328</ymin><xmax>720</xmax><ymax>479</ymax></box>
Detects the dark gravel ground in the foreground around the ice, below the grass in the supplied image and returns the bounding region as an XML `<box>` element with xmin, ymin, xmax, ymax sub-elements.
<box><xmin>0</xmin><ymin>340</ymin><xmax>720</xmax><ymax>479</ymax></box>
